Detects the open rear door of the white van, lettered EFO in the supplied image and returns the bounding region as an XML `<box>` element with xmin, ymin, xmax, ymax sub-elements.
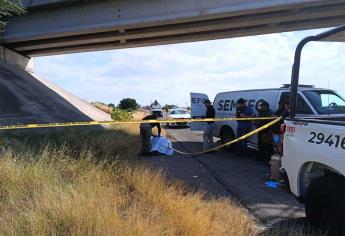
<box><xmin>190</xmin><ymin>93</ymin><xmax>208</xmax><ymax>131</ymax></box>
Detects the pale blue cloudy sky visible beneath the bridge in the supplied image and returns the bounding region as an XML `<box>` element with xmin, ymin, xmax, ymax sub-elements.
<box><xmin>35</xmin><ymin>27</ymin><xmax>345</xmax><ymax>106</ymax></box>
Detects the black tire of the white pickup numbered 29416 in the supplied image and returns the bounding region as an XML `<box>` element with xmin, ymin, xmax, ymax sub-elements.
<box><xmin>305</xmin><ymin>175</ymin><xmax>345</xmax><ymax>235</ymax></box>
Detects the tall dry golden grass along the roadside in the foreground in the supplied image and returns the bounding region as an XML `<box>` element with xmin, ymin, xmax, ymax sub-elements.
<box><xmin>0</xmin><ymin>126</ymin><xmax>257</xmax><ymax>235</ymax></box>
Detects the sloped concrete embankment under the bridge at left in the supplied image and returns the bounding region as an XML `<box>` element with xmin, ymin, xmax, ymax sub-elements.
<box><xmin>0</xmin><ymin>63</ymin><xmax>111</xmax><ymax>125</ymax></box>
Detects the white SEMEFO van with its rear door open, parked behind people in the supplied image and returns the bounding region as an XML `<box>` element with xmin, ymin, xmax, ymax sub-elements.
<box><xmin>190</xmin><ymin>85</ymin><xmax>345</xmax><ymax>147</ymax></box>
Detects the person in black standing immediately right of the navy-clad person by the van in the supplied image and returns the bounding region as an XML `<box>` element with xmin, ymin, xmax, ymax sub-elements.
<box><xmin>257</xmin><ymin>101</ymin><xmax>273</xmax><ymax>161</ymax></box>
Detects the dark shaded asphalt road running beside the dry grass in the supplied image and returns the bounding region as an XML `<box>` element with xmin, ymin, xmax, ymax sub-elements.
<box><xmin>145</xmin><ymin>128</ymin><xmax>305</xmax><ymax>228</ymax></box>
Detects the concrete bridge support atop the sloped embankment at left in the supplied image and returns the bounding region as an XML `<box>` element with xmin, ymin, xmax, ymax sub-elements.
<box><xmin>0</xmin><ymin>45</ymin><xmax>35</xmax><ymax>72</ymax></box>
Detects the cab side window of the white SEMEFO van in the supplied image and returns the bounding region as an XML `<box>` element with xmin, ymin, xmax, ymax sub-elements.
<box><xmin>303</xmin><ymin>90</ymin><xmax>345</xmax><ymax>114</ymax></box>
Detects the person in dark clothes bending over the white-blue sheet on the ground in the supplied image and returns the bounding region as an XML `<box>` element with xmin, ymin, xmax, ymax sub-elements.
<box><xmin>140</xmin><ymin>114</ymin><xmax>161</xmax><ymax>156</ymax></box>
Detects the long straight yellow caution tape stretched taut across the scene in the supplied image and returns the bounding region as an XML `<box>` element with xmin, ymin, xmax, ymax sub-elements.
<box><xmin>0</xmin><ymin>117</ymin><xmax>275</xmax><ymax>130</ymax></box>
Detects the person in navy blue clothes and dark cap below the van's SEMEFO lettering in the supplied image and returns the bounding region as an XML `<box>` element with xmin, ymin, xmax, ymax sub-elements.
<box><xmin>236</xmin><ymin>98</ymin><xmax>255</xmax><ymax>155</ymax></box>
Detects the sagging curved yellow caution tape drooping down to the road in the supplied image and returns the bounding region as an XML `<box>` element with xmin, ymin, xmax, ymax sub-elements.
<box><xmin>171</xmin><ymin>117</ymin><xmax>282</xmax><ymax>155</ymax></box>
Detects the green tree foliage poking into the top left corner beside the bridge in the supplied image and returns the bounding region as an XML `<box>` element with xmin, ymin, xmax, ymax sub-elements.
<box><xmin>0</xmin><ymin>0</ymin><xmax>26</xmax><ymax>38</ymax></box>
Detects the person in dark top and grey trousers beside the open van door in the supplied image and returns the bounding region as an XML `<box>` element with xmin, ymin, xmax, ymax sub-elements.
<box><xmin>202</xmin><ymin>99</ymin><xmax>216</xmax><ymax>151</ymax></box>
